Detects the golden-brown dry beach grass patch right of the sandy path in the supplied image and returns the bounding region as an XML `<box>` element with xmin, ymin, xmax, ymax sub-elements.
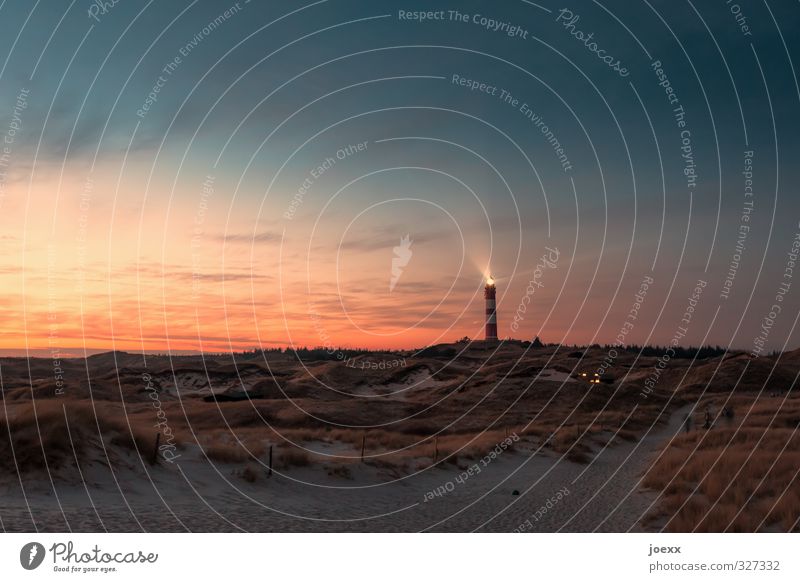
<box><xmin>644</xmin><ymin>397</ymin><xmax>800</xmax><ymax>532</ymax></box>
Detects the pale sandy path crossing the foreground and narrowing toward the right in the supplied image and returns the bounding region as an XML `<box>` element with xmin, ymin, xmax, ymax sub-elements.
<box><xmin>0</xmin><ymin>410</ymin><xmax>685</xmax><ymax>532</ymax></box>
